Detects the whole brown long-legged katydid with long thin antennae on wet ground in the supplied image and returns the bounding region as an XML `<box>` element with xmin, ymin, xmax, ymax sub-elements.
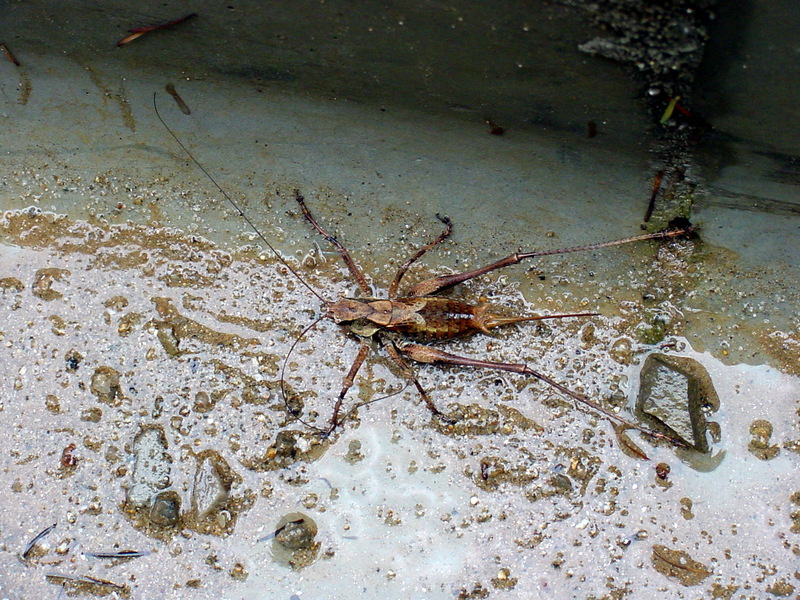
<box><xmin>153</xmin><ymin>95</ymin><xmax>692</xmax><ymax>447</ymax></box>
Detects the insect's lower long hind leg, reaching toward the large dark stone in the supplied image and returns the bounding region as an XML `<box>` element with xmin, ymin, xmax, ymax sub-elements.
<box><xmin>400</xmin><ymin>344</ymin><xmax>688</xmax><ymax>448</ymax></box>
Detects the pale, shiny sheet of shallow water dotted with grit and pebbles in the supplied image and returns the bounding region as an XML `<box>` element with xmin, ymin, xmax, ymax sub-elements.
<box><xmin>0</xmin><ymin>211</ymin><xmax>800</xmax><ymax>598</ymax></box>
